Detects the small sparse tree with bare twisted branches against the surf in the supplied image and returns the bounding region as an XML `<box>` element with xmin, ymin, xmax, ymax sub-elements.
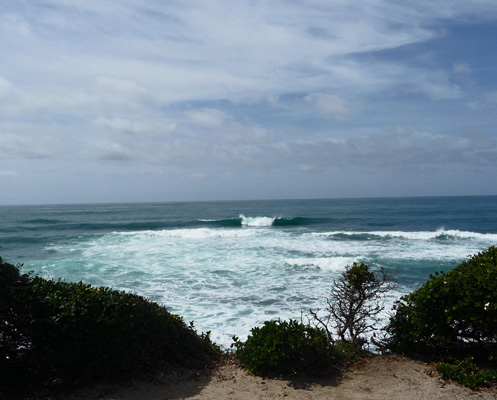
<box><xmin>310</xmin><ymin>263</ymin><xmax>394</xmax><ymax>347</ymax></box>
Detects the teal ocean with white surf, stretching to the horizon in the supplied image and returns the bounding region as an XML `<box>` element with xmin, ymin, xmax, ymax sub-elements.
<box><xmin>0</xmin><ymin>196</ymin><xmax>497</xmax><ymax>347</ymax></box>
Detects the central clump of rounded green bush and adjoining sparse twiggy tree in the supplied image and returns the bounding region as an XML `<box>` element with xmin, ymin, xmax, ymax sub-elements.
<box><xmin>233</xmin><ymin>263</ymin><xmax>393</xmax><ymax>376</ymax></box>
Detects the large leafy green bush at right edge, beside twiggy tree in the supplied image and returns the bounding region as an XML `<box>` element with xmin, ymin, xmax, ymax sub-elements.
<box><xmin>387</xmin><ymin>247</ymin><xmax>497</xmax><ymax>361</ymax></box>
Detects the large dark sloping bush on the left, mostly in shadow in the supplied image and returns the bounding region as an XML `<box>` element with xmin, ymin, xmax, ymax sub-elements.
<box><xmin>0</xmin><ymin>259</ymin><xmax>219</xmax><ymax>396</ymax></box>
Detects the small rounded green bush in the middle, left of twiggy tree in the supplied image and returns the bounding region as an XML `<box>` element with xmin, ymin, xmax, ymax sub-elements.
<box><xmin>233</xmin><ymin>320</ymin><xmax>338</xmax><ymax>376</ymax></box>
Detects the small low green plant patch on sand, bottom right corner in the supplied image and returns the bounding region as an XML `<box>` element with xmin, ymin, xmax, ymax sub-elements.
<box><xmin>437</xmin><ymin>357</ymin><xmax>497</xmax><ymax>389</ymax></box>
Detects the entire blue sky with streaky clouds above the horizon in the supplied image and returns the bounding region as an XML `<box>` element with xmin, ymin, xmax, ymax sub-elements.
<box><xmin>0</xmin><ymin>0</ymin><xmax>497</xmax><ymax>204</ymax></box>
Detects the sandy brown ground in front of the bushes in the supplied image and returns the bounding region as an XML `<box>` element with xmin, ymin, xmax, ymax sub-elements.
<box><xmin>60</xmin><ymin>356</ymin><xmax>497</xmax><ymax>400</ymax></box>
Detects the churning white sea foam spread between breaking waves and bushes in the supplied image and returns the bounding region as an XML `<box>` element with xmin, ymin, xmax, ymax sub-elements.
<box><xmin>35</xmin><ymin>225</ymin><xmax>497</xmax><ymax>347</ymax></box>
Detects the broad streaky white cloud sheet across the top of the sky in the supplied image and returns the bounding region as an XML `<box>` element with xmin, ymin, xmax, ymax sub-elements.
<box><xmin>1</xmin><ymin>1</ymin><xmax>489</xmax><ymax>108</ymax></box>
